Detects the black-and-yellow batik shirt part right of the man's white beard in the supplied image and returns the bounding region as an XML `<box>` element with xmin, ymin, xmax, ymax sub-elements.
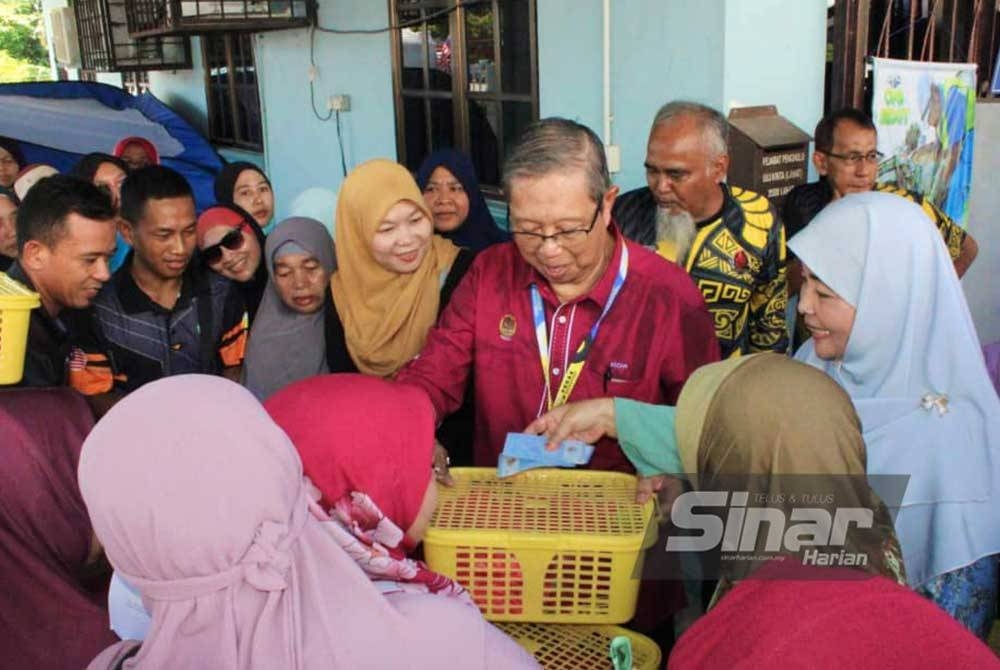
<box><xmin>664</xmin><ymin>186</ymin><xmax>788</xmax><ymax>358</ymax></box>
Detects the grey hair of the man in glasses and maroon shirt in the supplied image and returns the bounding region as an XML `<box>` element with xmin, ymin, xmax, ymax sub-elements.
<box><xmin>503</xmin><ymin>117</ymin><xmax>611</xmax><ymax>203</ymax></box>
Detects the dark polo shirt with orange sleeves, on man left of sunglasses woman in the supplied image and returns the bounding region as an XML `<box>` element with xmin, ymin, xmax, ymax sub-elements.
<box><xmin>74</xmin><ymin>256</ymin><xmax>247</xmax><ymax>394</ymax></box>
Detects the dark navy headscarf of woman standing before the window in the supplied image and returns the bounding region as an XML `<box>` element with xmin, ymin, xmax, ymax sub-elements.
<box><xmin>417</xmin><ymin>149</ymin><xmax>510</xmax><ymax>251</ymax></box>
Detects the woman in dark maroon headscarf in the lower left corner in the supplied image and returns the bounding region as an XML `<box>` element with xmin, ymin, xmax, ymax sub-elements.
<box><xmin>0</xmin><ymin>389</ymin><xmax>118</xmax><ymax>670</ymax></box>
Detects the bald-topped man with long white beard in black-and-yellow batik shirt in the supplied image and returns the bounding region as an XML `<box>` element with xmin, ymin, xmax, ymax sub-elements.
<box><xmin>613</xmin><ymin>102</ymin><xmax>788</xmax><ymax>358</ymax></box>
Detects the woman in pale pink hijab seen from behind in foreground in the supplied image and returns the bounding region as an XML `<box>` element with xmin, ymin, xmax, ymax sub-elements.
<box><xmin>79</xmin><ymin>375</ymin><xmax>534</xmax><ymax>670</ymax></box>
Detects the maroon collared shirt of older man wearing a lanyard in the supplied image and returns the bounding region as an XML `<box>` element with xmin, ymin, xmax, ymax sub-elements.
<box><xmin>397</xmin><ymin>228</ymin><xmax>719</xmax><ymax>472</ymax></box>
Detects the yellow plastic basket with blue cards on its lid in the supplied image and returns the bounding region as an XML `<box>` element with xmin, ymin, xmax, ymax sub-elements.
<box><xmin>424</xmin><ymin>468</ymin><xmax>656</xmax><ymax>623</ymax></box>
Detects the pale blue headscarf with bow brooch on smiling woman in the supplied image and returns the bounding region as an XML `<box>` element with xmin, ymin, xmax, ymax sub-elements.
<box><xmin>788</xmin><ymin>193</ymin><xmax>1000</xmax><ymax>586</ymax></box>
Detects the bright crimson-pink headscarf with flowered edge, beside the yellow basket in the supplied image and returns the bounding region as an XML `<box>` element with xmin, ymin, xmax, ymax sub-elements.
<box><xmin>264</xmin><ymin>374</ymin><xmax>472</xmax><ymax>605</ymax></box>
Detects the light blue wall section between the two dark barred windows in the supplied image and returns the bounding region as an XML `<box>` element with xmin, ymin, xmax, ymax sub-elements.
<box><xmin>256</xmin><ymin>0</ymin><xmax>396</xmax><ymax>224</ymax></box>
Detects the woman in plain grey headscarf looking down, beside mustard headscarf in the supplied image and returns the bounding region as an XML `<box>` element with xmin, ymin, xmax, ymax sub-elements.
<box><xmin>243</xmin><ymin>217</ymin><xmax>336</xmax><ymax>401</ymax></box>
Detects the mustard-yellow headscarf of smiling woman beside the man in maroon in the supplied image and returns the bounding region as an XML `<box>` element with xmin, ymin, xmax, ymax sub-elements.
<box><xmin>330</xmin><ymin>159</ymin><xmax>459</xmax><ymax>377</ymax></box>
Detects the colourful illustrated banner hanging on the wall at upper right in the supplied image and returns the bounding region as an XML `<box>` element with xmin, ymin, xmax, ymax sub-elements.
<box><xmin>872</xmin><ymin>58</ymin><xmax>976</xmax><ymax>227</ymax></box>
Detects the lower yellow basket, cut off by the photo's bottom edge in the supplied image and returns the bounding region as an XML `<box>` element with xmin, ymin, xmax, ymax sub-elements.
<box><xmin>497</xmin><ymin>622</ymin><xmax>663</xmax><ymax>670</ymax></box>
